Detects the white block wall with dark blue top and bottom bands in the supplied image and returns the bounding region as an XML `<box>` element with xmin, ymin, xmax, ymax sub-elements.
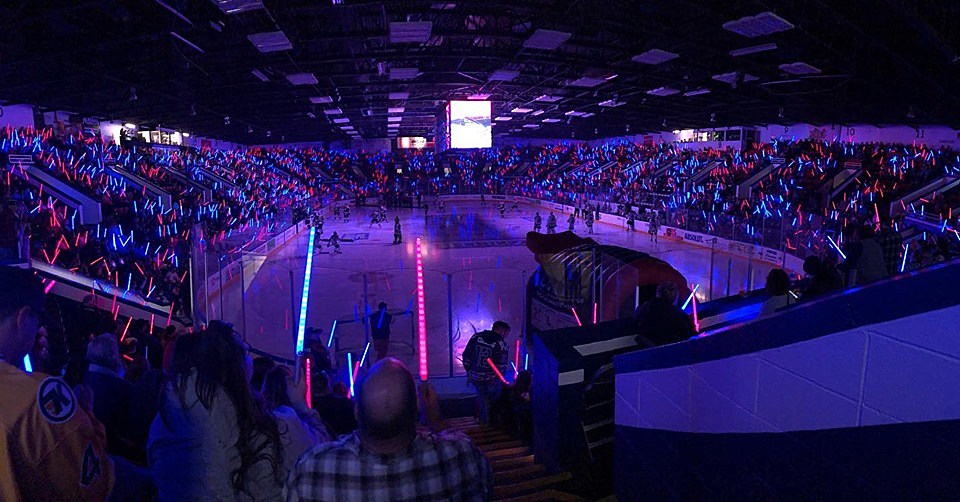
<box><xmin>615</xmin><ymin>263</ymin><xmax>960</xmax><ymax>500</ymax></box>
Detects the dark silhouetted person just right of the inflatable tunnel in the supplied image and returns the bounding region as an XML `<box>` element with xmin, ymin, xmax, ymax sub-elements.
<box><xmin>636</xmin><ymin>282</ymin><xmax>697</xmax><ymax>346</ymax></box>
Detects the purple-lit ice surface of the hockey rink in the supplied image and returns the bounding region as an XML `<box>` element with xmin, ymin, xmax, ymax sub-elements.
<box><xmin>208</xmin><ymin>200</ymin><xmax>772</xmax><ymax>376</ymax></box>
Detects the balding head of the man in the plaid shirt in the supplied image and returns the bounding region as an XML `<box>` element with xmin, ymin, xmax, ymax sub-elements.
<box><xmin>357</xmin><ymin>357</ymin><xmax>417</xmax><ymax>439</ymax></box>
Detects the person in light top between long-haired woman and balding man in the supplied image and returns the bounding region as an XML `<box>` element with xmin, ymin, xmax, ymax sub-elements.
<box><xmin>261</xmin><ymin>366</ymin><xmax>330</xmax><ymax>472</ymax></box>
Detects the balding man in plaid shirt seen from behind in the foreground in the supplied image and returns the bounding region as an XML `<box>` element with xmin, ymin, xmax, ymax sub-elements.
<box><xmin>288</xmin><ymin>358</ymin><xmax>493</xmax><ymax>501</ymax></box>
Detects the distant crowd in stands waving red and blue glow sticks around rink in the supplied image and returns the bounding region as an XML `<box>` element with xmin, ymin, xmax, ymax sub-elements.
<box><xmin>7</xmin><ymin>128</ymin><xmax>960</xmax><ymax>303</ymax></box>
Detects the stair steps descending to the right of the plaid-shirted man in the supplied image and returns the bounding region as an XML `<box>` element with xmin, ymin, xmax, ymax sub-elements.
<box><xmin>447</xmin><ymin>417</ymin><xmax>586</xmax><ymax>502</ymax></box>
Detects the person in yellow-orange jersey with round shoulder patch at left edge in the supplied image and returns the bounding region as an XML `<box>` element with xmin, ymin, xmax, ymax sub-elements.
<box><xmin>0</xmin><ymin>267</ymin><xmax>114</xmax><ymax>500</ymax></box>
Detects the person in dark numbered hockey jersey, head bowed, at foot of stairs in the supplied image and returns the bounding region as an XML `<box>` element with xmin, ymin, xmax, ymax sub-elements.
<box><xmin>462</xmin><ymin>321</ymin><xmax>510</xmax><ymax>424</ymax></box>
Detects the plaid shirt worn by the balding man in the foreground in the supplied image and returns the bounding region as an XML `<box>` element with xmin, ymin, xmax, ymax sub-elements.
<box><xmin>288</xmin><ymin>431</ymin><xmax>493</xmax><ymax>501</ymax></box>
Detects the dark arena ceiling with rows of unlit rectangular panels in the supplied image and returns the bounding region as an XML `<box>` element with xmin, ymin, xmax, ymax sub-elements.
<box><xmin>0</xmin><ymin>0</ymin><xmax>960</xmax><ymax>144</ymax></box>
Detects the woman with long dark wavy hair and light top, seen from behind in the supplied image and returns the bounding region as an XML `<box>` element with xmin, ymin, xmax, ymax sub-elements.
<box><xmin>147</xmin><ymin>321</ymin><xmax>286</xmax><ymax>501</ymax></box>
